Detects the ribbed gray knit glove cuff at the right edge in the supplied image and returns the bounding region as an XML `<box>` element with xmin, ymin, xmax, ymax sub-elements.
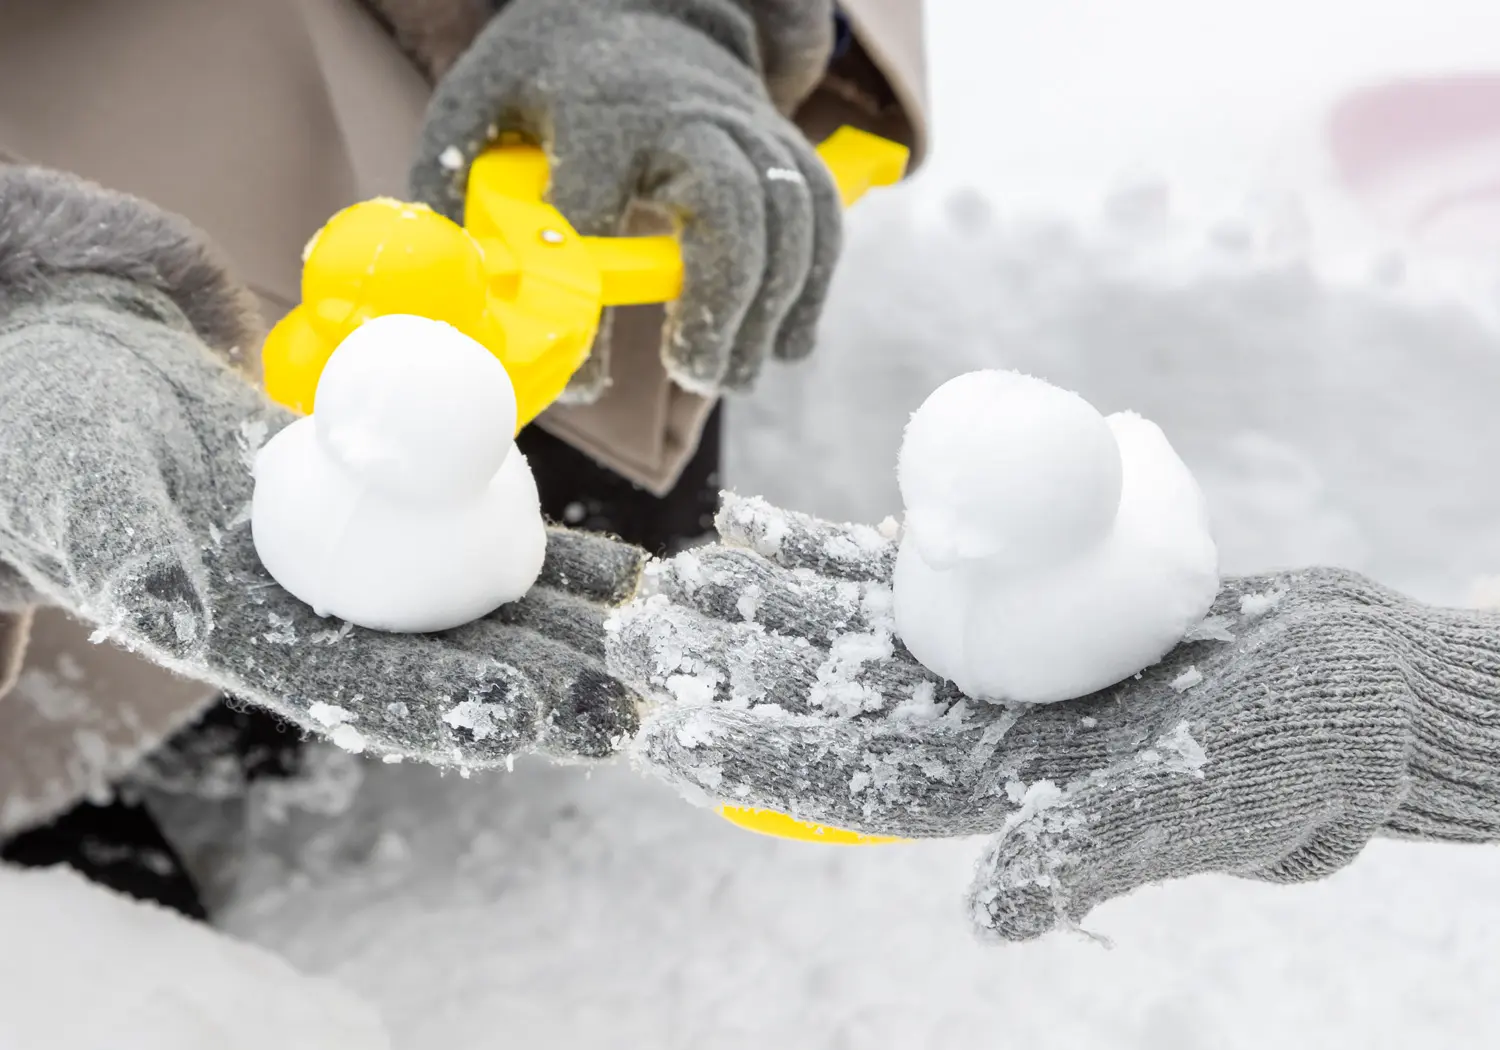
<box><xmin>1385</xmin><ymin>606</ymin><xmax>1500</xmax><ymax>842</ymax></box>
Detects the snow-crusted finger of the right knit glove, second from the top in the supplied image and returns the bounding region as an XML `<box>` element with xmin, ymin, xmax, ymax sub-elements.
<box><xmin>656</xmin><ymin>545</ymin><xmax>894</xmax><ymax>647</ymax></box>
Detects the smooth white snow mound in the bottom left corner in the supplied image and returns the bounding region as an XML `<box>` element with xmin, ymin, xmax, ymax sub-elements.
<box><xmin>0</xmin><ymin>867</ymin><xmax>392</xmax><ymax>1050</ymax></box>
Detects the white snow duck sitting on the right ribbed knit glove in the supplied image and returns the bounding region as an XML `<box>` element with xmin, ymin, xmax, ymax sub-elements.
<box><xmin>894</xmin><ymin>371</ymin><xmax>1220</xmax><ymax>704</ymax></box>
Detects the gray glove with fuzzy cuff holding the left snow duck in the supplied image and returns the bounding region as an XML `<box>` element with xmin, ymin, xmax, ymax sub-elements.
<box><xmin>0</xmin><ymin>167</ymin><xmax>644</xmax><ymax>767</ymax></box>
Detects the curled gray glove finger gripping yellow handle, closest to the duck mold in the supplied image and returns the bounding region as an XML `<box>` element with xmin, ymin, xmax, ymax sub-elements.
<box><xmin>645</xmin><ymin>123</ymin><xmax>768</xmax><ymax>395</ymax></box>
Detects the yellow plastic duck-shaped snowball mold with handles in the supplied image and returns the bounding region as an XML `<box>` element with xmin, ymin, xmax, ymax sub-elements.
<box><xmin>261</xmin><ymin>128</ymin><xmax>908</xmax><ymax>429</ymax></box>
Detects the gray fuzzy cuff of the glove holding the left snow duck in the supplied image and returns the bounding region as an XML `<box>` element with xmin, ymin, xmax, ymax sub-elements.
<box><xmin>0</xmin><ymin>165</ymin><xmax>263</xmax><ymax>362</ymax></box>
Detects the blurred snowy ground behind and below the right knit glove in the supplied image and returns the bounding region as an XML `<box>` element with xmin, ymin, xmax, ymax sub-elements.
<box><xmin>41</xmin><ymin>0</ymin><xmax>1500</xmax><ymax>1050</ymax></box>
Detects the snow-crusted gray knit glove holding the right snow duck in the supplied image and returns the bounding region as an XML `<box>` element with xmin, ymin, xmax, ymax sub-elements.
<box><xmin>609</xmin><ymin>498</ymin><xmax>1500</xmax><ymax>939</ymax></box>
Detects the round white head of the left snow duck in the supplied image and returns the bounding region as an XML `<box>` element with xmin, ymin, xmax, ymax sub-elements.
<box><xmin>314</xmin><ymin>314</ymin><xmax>516</xmax><ymax>500</ymax></box>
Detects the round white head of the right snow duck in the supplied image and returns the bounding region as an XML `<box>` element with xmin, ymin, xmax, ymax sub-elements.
<box><xmin>897</xmin><ymin>371</ymin><xmax>1121</xmax><ymax>567</ymax></box>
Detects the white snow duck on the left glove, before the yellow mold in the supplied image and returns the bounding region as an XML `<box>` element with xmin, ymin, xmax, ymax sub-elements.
<box><xmin>251</xmin><ymin>314</ymin><xmax>546</xmax><ymax>632</ymax></box>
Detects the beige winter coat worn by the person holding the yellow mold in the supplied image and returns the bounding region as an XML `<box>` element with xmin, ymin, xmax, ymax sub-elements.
<box><xmin>0</xmin><ymin>0</ymin><xmax>926</xmax><ymax>836</ymax></box>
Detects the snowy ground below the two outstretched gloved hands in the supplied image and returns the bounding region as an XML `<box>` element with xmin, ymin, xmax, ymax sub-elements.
<box><xmin>230</xmin><ymin>750</ymin><xmax>1500</xmax><ymax>1050</ymax></box>
